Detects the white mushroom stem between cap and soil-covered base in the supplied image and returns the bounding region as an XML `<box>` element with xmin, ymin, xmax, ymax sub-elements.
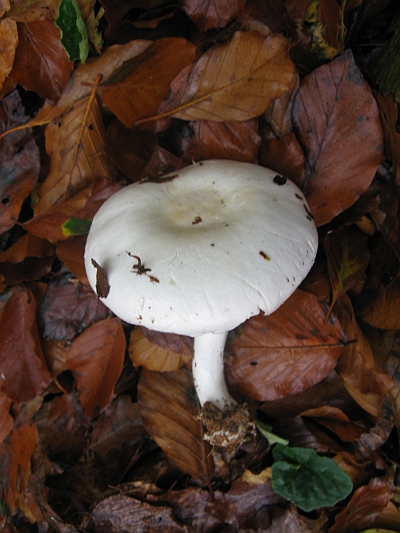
<box><xmin>192</xmin><ymin>331</ymin><xmax>236</xmax><ymax>411</ymax></box>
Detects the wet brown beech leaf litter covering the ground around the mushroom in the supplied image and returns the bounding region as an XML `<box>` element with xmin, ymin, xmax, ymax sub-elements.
<box><xmin>0</xmin><ymin>0</ymin><xmax>400</xmax><ymax>533</ymax></box>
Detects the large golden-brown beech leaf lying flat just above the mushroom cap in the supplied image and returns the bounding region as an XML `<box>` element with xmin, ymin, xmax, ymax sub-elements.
<box><xmin>158</xmin><ymin>31</ymin><xmax>295</xmax><ymax>122</ymax></box>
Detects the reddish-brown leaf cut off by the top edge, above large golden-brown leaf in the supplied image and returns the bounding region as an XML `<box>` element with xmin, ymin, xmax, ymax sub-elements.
<box><xmin>182</xmin><ymin>0</ymin><xmax>245</xmax><ymax>30</ymax></box>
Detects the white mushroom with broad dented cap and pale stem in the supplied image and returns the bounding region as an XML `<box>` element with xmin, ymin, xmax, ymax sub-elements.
<box><xmin>85</xmin><ymin>160</ymin><xmax>318</xmax><ymax>441</ymax></box>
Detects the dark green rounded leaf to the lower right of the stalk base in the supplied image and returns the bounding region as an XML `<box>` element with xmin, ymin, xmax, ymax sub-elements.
<box><xmin>272</xmin><ymin>444</ymin><xmax>353</xmax><ymax>512</ymax></box>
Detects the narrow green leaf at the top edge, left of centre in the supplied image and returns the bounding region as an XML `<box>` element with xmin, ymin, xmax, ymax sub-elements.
<box><xmin>54</xmin><ymin>0</ymin><xmax>89</xmax><ymax>63</ymax></box>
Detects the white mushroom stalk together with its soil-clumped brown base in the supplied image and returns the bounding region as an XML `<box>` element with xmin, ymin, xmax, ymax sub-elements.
<box><xmin>192</xmin><ymin>332</ymin><xmax>254</xmax><ymax>448</ymax></box>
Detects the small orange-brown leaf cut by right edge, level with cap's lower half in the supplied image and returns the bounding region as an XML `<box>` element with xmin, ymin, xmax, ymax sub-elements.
<box><xmin>357</xmin><ymin>280</ymin><xmax>400</xmax><ymax>329</ymax></box>
